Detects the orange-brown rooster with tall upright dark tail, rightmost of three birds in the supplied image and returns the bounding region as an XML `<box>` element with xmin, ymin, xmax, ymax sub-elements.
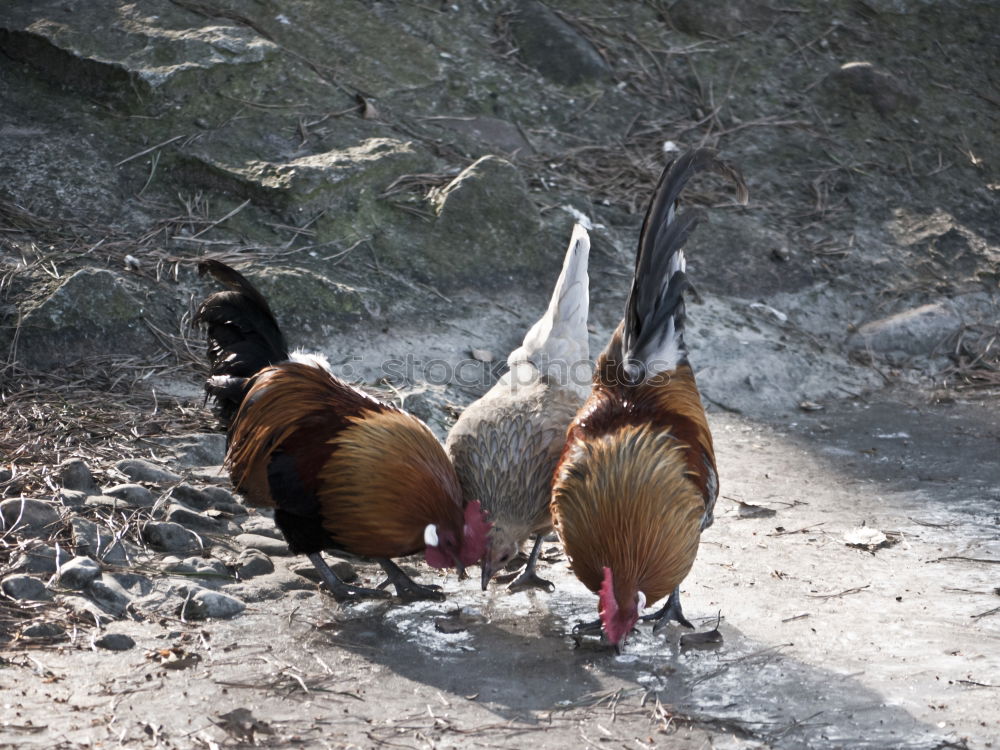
<box><xmin>552</xmin><ymin>149</ymin><xmax>747</xmax><ymax>651</ymax></box>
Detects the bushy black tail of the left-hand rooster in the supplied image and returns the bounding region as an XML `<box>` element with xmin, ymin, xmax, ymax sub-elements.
<box><xmin>195</xmin><ymin>260</ymin><xmax>288</xmax><ymax>429</ymax></box>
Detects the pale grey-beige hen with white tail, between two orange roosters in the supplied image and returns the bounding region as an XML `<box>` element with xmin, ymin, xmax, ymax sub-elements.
<box><xmin>445</xmin><ymin>224</ymin><xmax>590</xmax><ymax>591</ymax></box>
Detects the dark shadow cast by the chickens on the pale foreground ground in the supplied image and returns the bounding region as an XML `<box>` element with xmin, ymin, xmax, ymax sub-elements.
<box><xmin>316</xmin><ymin>591</ymin><xmax>950</xmax><ymax>748</ymax></box>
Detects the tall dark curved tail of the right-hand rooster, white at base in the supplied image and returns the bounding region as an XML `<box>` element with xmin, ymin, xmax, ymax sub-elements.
<box><xmin>622</xmin><ymin>149</ymin><xmax>748</xmax><ymax>383</ymax></box>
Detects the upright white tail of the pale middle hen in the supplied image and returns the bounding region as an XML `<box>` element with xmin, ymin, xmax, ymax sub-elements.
<box><xmin>507</xmin><ymin>224</ymin><xmax>590</xmax><ymax>374</ymax></box>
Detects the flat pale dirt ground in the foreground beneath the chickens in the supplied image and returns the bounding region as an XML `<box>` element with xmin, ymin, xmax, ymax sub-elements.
<box><xmin>0</xmin><ymin>394</ymin><xmax>1000</xmax><ymax>748</ymax></box>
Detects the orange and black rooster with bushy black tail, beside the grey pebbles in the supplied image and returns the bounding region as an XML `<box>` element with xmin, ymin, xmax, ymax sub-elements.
<box><xmin>196</xmin><ymin>260</ymin><xmax>490</xmax><ymax>601</ymax></box>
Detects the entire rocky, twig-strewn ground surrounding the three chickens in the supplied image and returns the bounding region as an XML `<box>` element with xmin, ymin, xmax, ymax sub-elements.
<box><xmin>0</xmin><ymin>0</ymin><xmax>1000</xmax><ymax>748</ymax></box>
